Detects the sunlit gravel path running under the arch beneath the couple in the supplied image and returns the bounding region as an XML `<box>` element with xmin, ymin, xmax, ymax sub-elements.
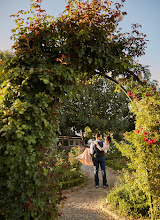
<box><xmin>59</xmin><ymin>165</ymin><xmax>120</xmax><ymax>220</ymax></box>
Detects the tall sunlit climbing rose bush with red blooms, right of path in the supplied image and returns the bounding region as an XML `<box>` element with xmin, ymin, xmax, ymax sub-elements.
<box><xmin>109</xmin><ymin>85</ymin><xmax>160</xmax><ymax>219</ymax></box>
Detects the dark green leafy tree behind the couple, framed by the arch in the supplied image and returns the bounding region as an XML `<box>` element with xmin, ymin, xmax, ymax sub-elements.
<box><xmin>60</xmin><ymin>77</ymin><xmax>134</xmax><ymax>137</ymax></box>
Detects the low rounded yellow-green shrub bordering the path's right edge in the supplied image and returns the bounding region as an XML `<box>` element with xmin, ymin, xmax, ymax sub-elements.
<box><xmin>107</xmin><ymin>170</ymin><xmax>149</xmax><ymax>218</ymax></box>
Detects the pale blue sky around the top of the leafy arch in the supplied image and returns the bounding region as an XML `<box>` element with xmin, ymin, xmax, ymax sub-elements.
<box><xmin>0</xmin><ymin>0</ymin><xmax>160</xmax><ymax>86</ymax></box>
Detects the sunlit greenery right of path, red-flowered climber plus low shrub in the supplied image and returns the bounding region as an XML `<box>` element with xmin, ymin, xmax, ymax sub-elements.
<box><xmin>108</xmin><ymin>85</ymin><xmax>160</xmax><ymax>219</ymax></box>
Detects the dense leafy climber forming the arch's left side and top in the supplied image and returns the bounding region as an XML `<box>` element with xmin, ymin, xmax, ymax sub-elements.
<box><xmin>0</xmin><ymin>0</ymin><xmax>154</xmax><ymax>220</ymax></box>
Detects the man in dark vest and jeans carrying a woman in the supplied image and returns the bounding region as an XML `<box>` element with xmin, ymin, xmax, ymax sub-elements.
<box><xmin>90</xmin><ymin>133</ymin><xmax>109</xmax><ymax>188</ymax></box>
